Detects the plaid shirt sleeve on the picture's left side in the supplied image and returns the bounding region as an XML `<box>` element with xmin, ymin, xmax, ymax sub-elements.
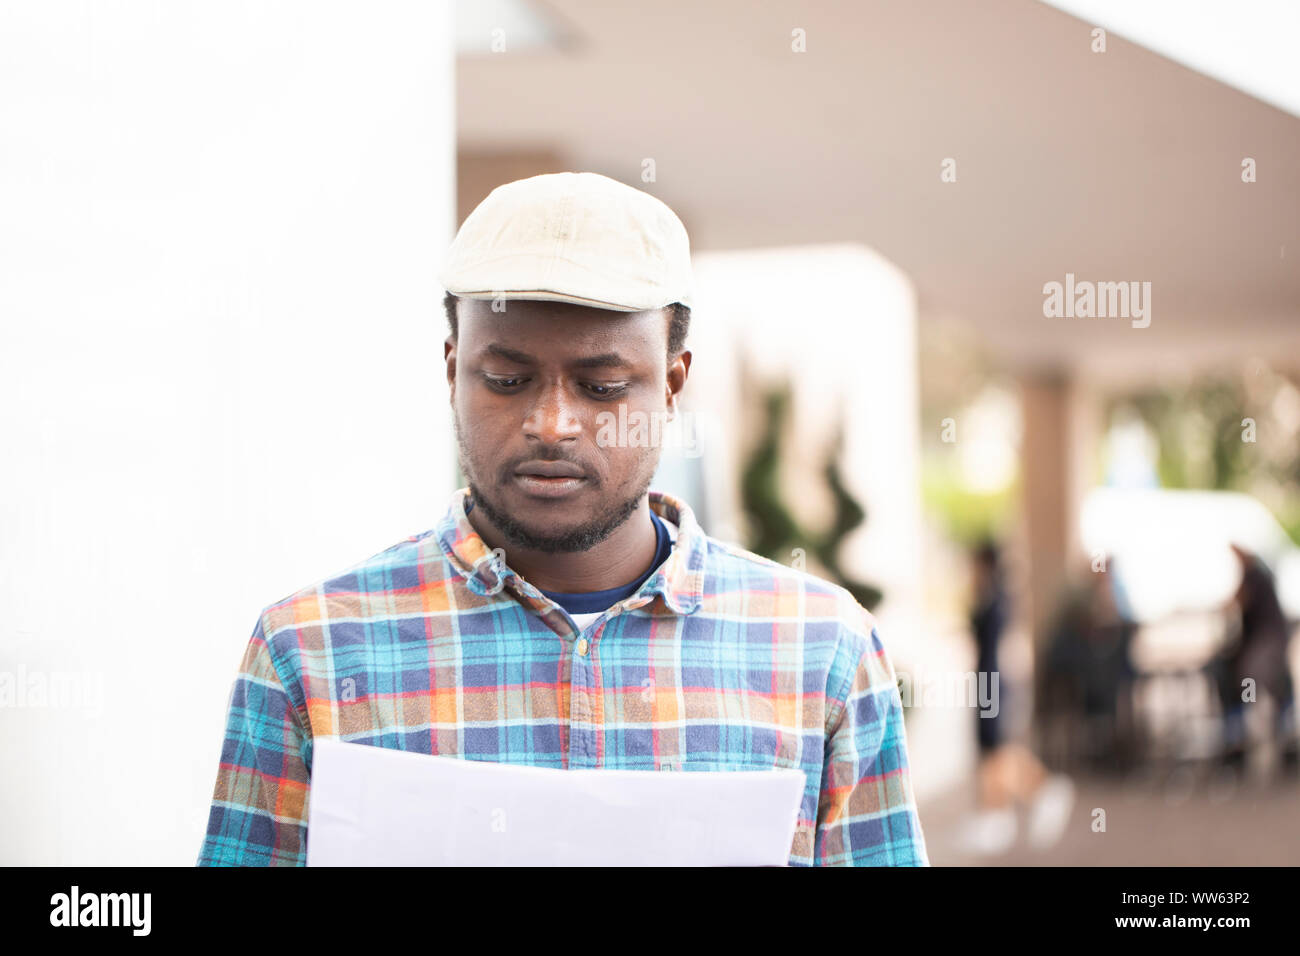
<box><xmin>198</xmin><ymin>619</ymin><xmax>311</xmax><ymax>866</ymax></box>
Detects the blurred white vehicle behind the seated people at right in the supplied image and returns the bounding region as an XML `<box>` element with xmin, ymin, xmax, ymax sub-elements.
<box><xmin>1080</xmin><ymin>488</ymin><xmax>1300</xmax><ymax>667</ymax></box>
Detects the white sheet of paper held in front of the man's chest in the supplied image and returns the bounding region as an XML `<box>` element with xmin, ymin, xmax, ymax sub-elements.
<box><xmin>307</xmin><ymin>737</ymin><xmax>806</xmax><ymax>866</ymax></box>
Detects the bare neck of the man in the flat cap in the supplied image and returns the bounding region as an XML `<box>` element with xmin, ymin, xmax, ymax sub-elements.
<box><xmin>469</xmin><ymin>497</ymin><xmax>657</xmax><ymax>594</ymax></box>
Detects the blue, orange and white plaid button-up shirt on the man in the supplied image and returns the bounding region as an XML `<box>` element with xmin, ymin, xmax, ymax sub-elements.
<box><xmin>199</xmin><ymin>488</ymin><xmax>930</xmax><ymax>866</ymax></box>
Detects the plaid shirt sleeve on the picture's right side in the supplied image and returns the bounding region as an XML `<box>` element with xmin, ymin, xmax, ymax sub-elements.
<box><xmin>813</xmin><ymin>611</ymin><xmax>930</xmax><ymax>866</ymax></box>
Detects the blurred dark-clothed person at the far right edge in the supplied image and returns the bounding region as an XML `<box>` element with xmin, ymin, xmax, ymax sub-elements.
<box><xmin>1206</xmin><ymin>545</ymin><xmax>1300</xmax><ymax>774</ymax></box>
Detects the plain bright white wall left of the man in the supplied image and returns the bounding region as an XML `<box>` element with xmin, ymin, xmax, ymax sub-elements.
<box><xmin>0</xmin><ymin>0</ymin><xmax>455</xmax><ymax>865</ymax></box>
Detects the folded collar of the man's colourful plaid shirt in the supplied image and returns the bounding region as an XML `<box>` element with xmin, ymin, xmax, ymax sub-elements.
<box><xmin>437</xmin><ymin>488</ymin><xmax>707</xmax><ymax>614</ymax></box>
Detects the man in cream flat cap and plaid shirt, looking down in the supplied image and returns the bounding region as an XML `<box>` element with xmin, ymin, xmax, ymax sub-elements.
<box><xmin>199</xmin><ymin>173</ymin><xmax>928</xmax><ymax>866</ymax></box>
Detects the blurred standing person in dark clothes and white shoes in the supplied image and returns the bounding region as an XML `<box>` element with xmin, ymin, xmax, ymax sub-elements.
<box><xmin>962</xmin><ymin>540</ymin><xmax>1074</xmax><ymax>855</ymax></box>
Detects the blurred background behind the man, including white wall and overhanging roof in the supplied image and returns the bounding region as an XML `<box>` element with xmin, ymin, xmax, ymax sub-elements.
<box><xmin>0</xmin><ymin>0</ymin><xmax>1300</xmax><ymax>865</ymax></box>
